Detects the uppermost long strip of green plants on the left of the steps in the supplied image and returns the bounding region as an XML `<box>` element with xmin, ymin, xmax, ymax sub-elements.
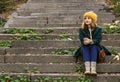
<box><xmin>2</xmin><ymin>28</ymin><xmax>37</xmax><ymax>34</ymax></box>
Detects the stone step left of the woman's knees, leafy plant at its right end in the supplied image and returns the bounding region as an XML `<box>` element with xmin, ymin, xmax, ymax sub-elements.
<box><xmin>5</xmin><ymin>47</ymin><xmax>78</xmax><ymax>55</ymax></box>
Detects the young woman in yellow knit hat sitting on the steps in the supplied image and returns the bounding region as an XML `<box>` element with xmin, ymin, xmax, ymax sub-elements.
<box><xmin>75</xmin><ymin>11</ymin><xmax>110</xmax><ymax>75</ymax></box>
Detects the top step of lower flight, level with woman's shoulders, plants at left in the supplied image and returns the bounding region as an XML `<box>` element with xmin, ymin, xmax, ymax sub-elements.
<box><xmin>0</xmin><ymin>25</ymin><xmax>110</xmax><ymax>34</ymax></box>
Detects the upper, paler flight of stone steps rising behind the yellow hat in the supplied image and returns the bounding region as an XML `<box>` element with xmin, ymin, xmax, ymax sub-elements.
<box><xmin>6</xmin><ymin>0</ymin><xmax>115</xmax><ymax>28</ymax></box>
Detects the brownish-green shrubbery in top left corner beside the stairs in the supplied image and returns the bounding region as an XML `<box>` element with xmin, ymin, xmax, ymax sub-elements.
<box><xmin>0</xmin><ymin>0</ymin><xmax>27</xmax><ymax>27</ymax></box>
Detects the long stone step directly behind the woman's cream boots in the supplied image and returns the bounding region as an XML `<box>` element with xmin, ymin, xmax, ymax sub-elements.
<box><xmin>0</xmin><ymin>63</ymin><xmax>120</xmax><ymax>73</ymax></box>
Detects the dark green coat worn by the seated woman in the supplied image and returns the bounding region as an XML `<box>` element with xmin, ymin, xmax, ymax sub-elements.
<box><xmin>75</xmin><ymin>27</ymin><xmax>111</xmax><ymax>57</ymax></box>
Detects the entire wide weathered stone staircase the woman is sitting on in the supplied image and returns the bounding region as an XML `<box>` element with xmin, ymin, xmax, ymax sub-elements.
<box><xmin>0</xmin><ymin>0</ymin><xmax>120</xmax><ymax>82</ymax></box>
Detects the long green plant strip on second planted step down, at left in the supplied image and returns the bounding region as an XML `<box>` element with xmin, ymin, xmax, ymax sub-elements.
<box><xmin>12</xmin><ymin>34</ymin><xmax>45</xmax><ymax>40</ymax></box>
